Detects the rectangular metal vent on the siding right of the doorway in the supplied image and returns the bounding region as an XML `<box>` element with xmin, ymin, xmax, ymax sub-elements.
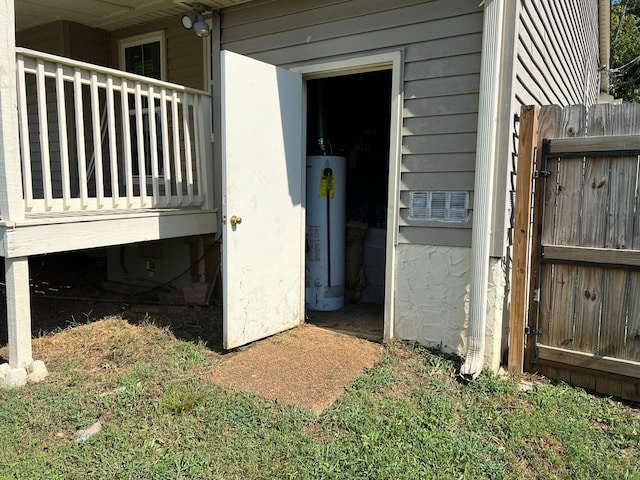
<box><xmin>409</xmin><ymin>192</ymin><xmax>469</xmax><ymax>222</ymax></box>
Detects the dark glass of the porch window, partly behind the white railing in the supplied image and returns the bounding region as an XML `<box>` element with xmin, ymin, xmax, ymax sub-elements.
<box><xmin>120</xmin><ymin>32</ymin><xmax>166</xmax><ymax>179</ymax></box>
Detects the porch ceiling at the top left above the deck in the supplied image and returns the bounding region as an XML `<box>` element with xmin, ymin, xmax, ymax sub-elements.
<box><xmin>14</xmin><ymin>0</ymin><xmax>250</xmax><ymax>31</ymax></box>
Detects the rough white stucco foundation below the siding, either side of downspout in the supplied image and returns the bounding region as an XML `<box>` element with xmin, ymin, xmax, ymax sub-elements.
<box><xmin>394</xmin><ymin>244</ymin><xmax>505</xmax><ymax>371</ymax></box>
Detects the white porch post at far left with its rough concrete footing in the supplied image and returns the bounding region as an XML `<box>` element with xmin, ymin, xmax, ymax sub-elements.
<box><xmin>0</xmin><ymin>0</ymin><xmax>47</xmax><ymax>387</ymax></box>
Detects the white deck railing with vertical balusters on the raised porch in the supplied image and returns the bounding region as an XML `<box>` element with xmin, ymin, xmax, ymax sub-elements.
<box><xmin>16</xmin><ymin>48</ymin><xmax>211</xmax><ymax>213</ymax></box>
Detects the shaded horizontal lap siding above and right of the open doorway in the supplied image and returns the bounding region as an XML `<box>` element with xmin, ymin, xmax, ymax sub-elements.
<box><xmin>221</xmin><ymin>0</ymin><xmax>483</xmax><ymax>246</ymax></box>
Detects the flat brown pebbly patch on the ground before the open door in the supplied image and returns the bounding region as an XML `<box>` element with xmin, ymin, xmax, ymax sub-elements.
<box><xmin>210</xmin><ymin>325</ymin><xmax>382</xmax><ymax>415</ymax></box>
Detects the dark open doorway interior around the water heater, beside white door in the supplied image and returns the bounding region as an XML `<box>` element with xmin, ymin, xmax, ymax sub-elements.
<box><xmin>305</xmin><ymin>69</ymin><xmax>392</xmax><ymax>341</ymax></box>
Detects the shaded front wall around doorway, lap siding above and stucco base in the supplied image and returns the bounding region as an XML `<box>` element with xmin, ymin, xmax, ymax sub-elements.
<box><xmin>221</xmin><ymin>0</ymin><xmax>488</xmax><ymax>365</ymax></box>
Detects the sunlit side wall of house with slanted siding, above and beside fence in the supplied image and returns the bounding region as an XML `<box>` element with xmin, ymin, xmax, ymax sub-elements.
<box><xmin>493</xmin><ymin>0</ymin><xmax>600</xmax><ymax>256</ymax></box>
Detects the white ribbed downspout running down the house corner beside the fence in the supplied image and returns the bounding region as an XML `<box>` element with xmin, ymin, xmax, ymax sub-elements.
<box><xmin>460</xmin><ymin>0</ymin><xmax>506</xmax><ymax>381</ymax></box>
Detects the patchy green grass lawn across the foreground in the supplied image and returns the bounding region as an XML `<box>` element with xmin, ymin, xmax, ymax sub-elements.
<box><xmin>0</xmin><ymin>318</ymin><xmax>640</xmax><ymax>480</ymax></box>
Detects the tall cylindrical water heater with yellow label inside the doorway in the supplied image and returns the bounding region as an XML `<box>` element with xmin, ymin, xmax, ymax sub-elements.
<box><xmin>305</xmin><ymin>155</ymin><xmax>347</xmax><ymax>311</ymax></box>
